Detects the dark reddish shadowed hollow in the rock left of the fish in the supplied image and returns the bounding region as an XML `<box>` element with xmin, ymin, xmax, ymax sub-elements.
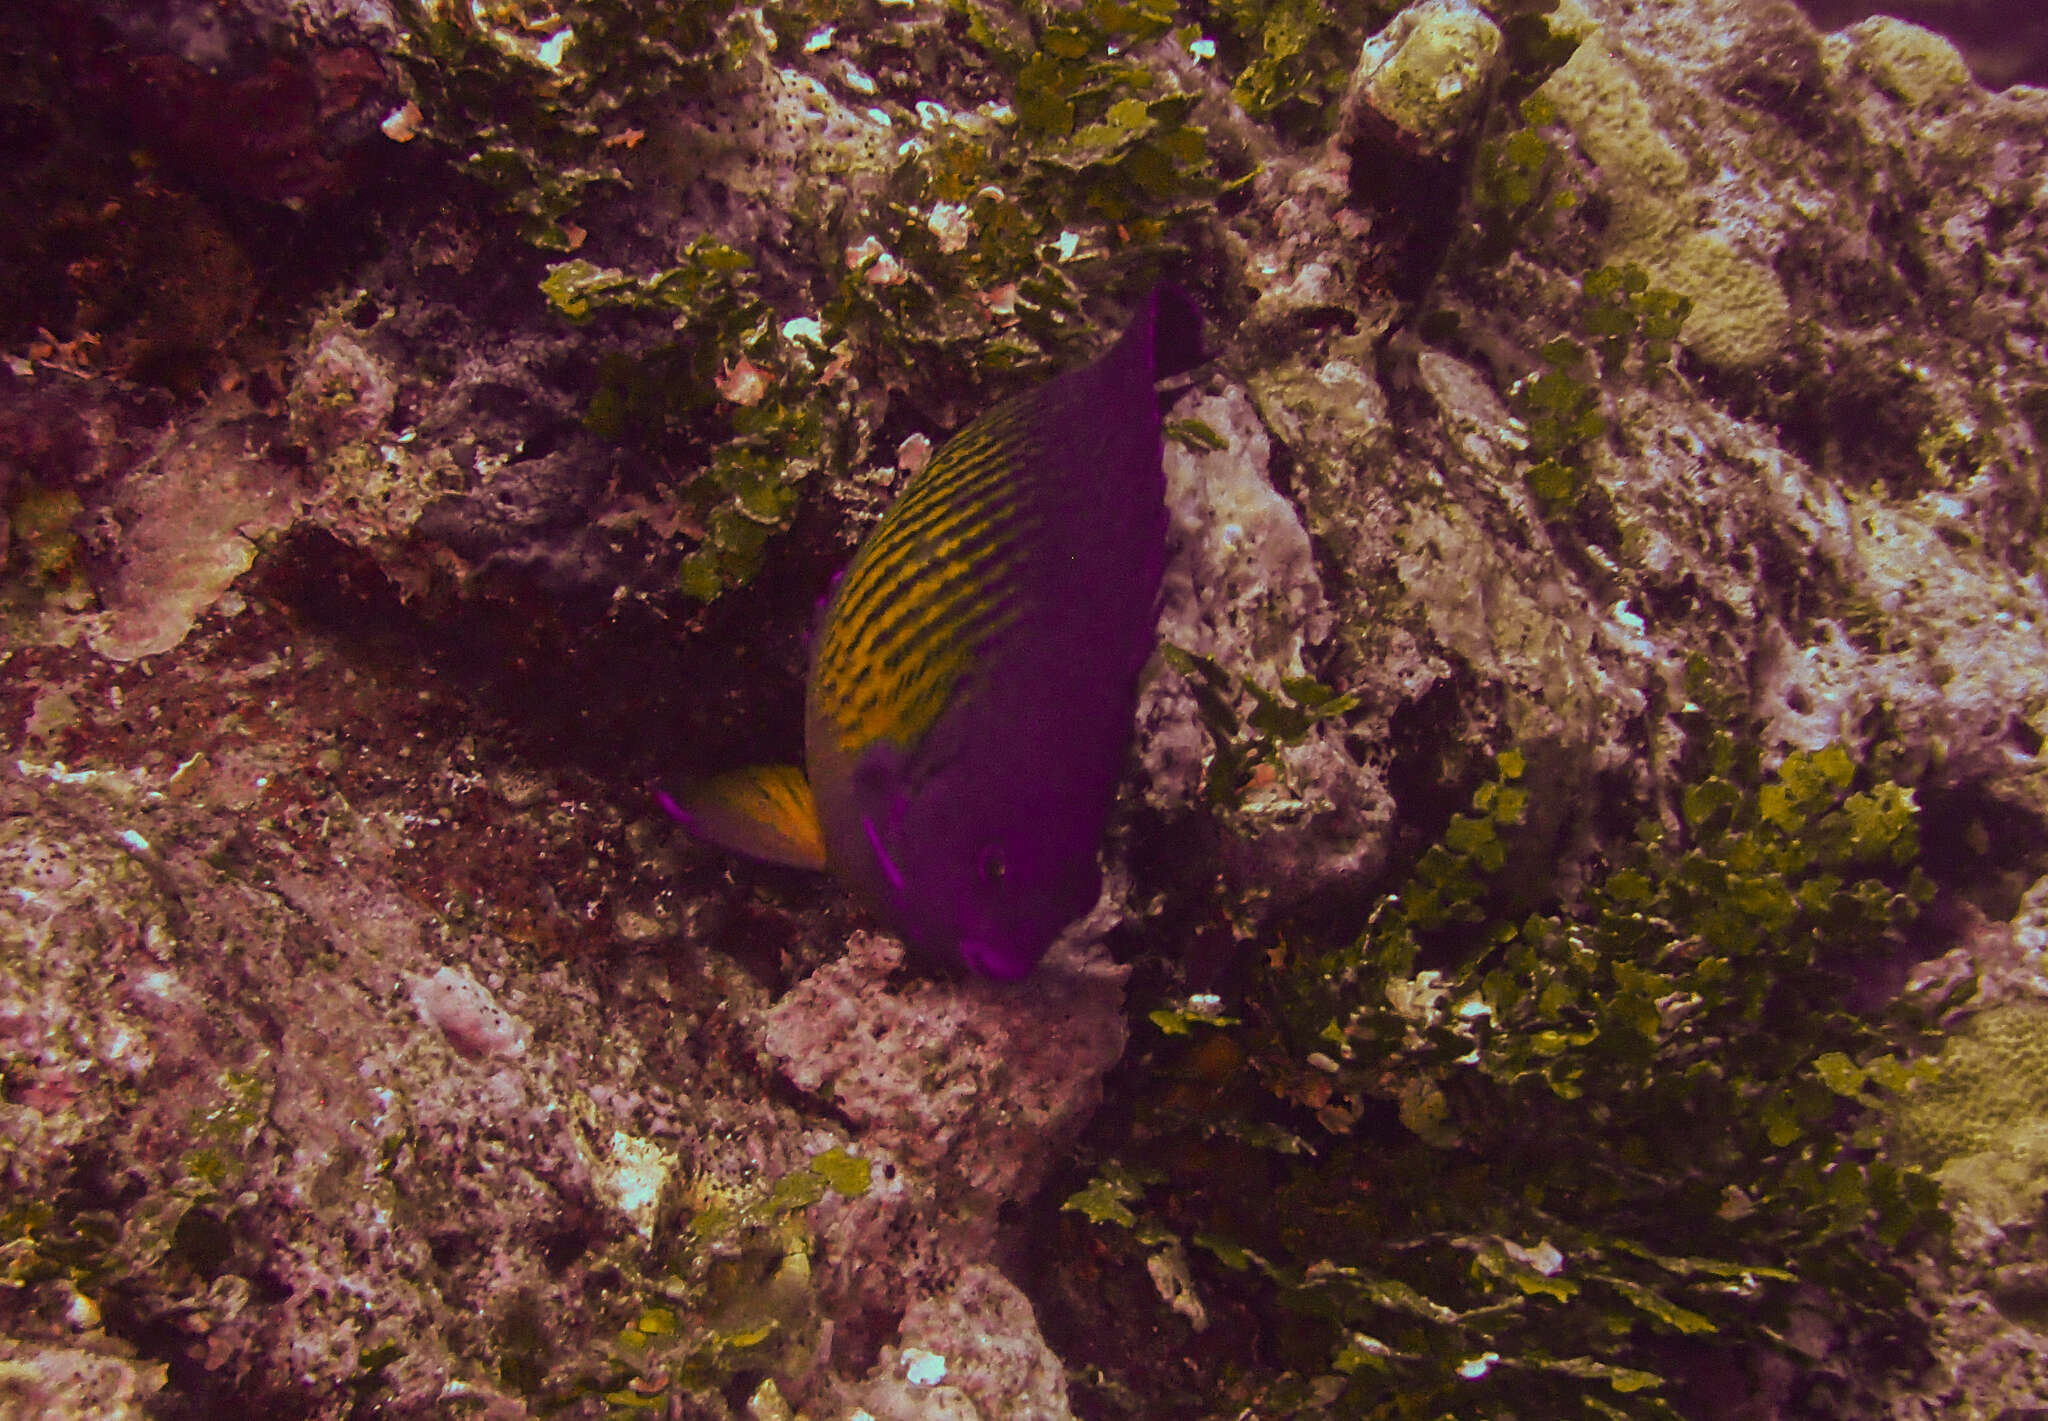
<box><xmin>252</xmin><ymin>528</ymin><xmax>840</xmax><ymax>991</ymax></box>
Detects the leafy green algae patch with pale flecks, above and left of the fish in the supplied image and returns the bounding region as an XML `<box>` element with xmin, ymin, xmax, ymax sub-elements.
<box><xmin>401</xmin><ymin>0</ymin><xmax>1223</xmax><ymax>602</ymax></box>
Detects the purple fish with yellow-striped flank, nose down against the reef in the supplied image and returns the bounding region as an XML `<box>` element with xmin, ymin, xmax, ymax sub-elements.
<box><xmin>659</xmin><ymin>283</ymin><xmax>1208</xmax><ymax>981</ymax></box>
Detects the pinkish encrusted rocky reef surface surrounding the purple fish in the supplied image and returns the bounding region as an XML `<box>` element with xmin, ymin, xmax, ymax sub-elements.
<box><xmin>0</xmin><ymin>0</ymin><xmax>2048</xmax><ymax>1421</ymax></box>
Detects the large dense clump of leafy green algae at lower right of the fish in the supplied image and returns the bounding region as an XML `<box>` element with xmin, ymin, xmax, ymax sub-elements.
<box><xmin>1061</xmin><ymin>737</ymin><xmax>1941</xmax><ymax>1417</ymax></box>
